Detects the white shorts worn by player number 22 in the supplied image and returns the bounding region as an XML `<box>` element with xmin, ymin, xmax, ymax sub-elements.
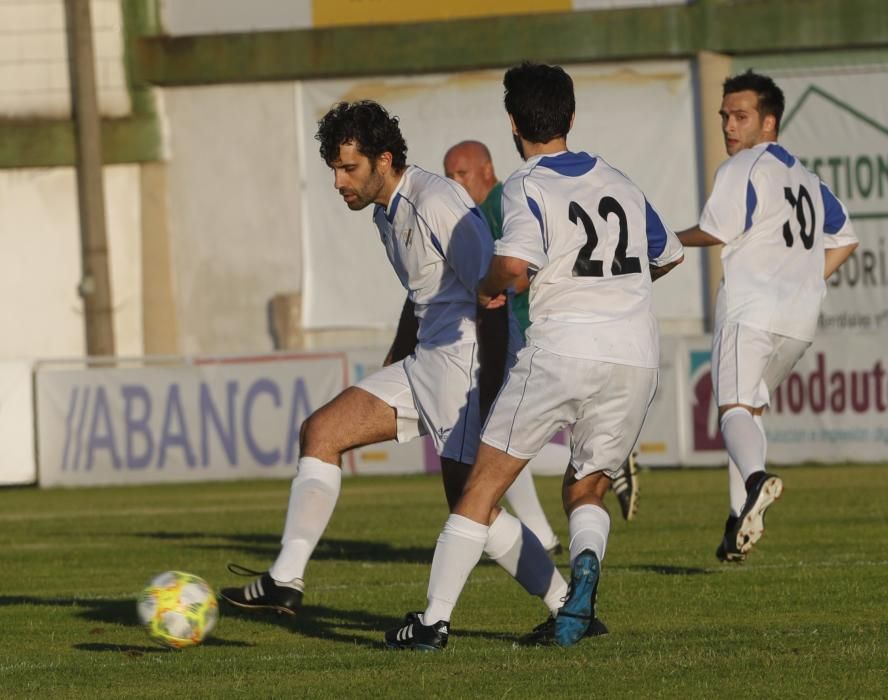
<box><xmin>481</xmin><ymin>345</ymin><xmax>658</xmax><ymax>479</ymax></box>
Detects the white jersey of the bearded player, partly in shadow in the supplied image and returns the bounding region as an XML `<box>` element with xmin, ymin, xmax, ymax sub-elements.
<box><xmin>373</xmin><ymin>165</ymin><xmax>493</xmax><ymax>345</ymax></box>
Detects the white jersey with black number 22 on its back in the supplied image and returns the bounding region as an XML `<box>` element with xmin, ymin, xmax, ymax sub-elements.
<box><xmin>495</xmin><ymin>151</ymin><xmax>683</xmax><ymax>368</ymax></box>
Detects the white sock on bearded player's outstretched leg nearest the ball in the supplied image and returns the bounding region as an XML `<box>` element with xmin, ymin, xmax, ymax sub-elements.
<box><xmin>269</xmin><ymin>457</ymin><xmax>342</xmax><ymax>587</ymax></box>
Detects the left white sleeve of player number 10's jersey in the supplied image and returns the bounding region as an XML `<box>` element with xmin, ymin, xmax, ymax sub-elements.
<box><xmin>700</xmin><ymin>154</ymin><xmax>756</xmax><ymax>243</ymax></box>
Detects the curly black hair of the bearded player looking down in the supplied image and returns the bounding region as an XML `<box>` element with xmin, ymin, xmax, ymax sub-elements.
<box><xmin>315</xmin><ymin>100</ymin><xmax>407</xmax><ymax>171</ymax></box>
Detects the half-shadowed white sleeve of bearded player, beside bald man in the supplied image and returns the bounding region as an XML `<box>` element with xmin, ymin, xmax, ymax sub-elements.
<box><xmin>423</xmin><ymin>190</ymin><xmax>493</xmax><ymax>292</ymax></box>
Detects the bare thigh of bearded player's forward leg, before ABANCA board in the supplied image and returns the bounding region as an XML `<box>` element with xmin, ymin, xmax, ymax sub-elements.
<box><xmin>302</xmin><ymin>385</ymin><xmax>395</xmax><ymax>455</ymax></box>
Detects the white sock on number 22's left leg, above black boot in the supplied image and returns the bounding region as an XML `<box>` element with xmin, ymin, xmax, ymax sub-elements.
<box><xmin>422</xmin><ymin>514</ymin><xmax>489</xmax><ymax>625</ymax></box>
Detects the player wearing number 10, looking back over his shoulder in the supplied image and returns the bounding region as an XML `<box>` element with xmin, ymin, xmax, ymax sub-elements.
<box><xmin>679</xmin><ymin>71</ymin><xmax>857</xmax><ymax>561</ymax></box>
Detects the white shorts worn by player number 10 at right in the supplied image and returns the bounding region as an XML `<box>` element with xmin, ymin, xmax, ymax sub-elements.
<box><xmin>712</xmin><ymin>323</ymin><xmax>811</xmax><ymax>408</ymax></box>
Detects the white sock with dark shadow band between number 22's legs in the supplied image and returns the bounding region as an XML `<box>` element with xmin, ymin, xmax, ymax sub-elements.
<box><xmin>484</xmin><ymin>510</ymin><xmax>567</xmax><ymax>613</ymax></box>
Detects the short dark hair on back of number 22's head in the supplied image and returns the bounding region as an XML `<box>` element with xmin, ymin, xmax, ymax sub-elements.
<box><xmin>503</xmin><ymin>61</ymin><xmax>576</xmax><ymax>143</ymax></box>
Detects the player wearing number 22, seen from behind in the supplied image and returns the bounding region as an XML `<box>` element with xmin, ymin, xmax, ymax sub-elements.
<box><xmin>386</xmin><ymin>63</ymin><xmax>683</xmax><ymax>649</ymax></box>
